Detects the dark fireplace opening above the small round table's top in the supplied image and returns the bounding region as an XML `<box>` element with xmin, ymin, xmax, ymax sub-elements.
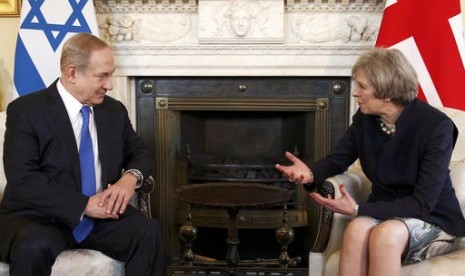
<box><xmin>180</xmin><ymin>111</ymin><xmax>314</xmax><ymax>208</ymax></box>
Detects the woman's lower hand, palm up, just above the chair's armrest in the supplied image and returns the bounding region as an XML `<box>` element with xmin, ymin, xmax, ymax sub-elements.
<box><xmin>310</xmin><ymin>184</ymin><xmax>357</xmax><ymax>216</ymax></box>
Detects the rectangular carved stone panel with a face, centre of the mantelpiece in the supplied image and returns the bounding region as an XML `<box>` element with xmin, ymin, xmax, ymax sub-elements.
<box><xmin>199</xmin><ymin>0</ymin><xmax>284</xmax><ymax>43</ymax></box>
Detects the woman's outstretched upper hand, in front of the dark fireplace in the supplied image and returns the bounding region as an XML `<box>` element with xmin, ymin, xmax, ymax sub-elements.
<box><xmin>275</xmin><ymin>151</ymin><xmax>313</xmax><ymax>184</ymax></box>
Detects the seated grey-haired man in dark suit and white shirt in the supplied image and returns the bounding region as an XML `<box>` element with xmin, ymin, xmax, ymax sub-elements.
<box><xmin>0</xmin><ymin>33</ymin><xmax>165</xmax><ymax>276</ymax></box>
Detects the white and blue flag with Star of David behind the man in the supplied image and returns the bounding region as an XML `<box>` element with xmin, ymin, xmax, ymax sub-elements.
<box><xmin>14</xmin><ymin>0</ymin><xmax>98</xmax><ymax>97</ymax></box>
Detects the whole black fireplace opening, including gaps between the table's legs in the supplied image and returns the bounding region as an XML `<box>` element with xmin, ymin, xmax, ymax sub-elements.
<box><xmin>176</xmin><ymin>110</ymin><xmax>315</xmax><ymax>267</ymax></box>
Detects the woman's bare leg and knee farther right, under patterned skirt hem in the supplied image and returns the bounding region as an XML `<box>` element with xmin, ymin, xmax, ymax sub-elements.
<box><xmin>368</xmin><ymin>219</ymin><xmax>409</xmax><ymax>276</ymax></box>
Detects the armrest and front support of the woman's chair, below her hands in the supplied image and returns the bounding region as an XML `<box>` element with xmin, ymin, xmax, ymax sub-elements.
<box><xmin>310</xmin><ymin>169</ymin><xmax>371</xmax><ymax>257</ymax></box>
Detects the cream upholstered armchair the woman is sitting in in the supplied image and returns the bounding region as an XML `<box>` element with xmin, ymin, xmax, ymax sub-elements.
<box><xmin>309</xmin><ymin>108</ymin><xmax>465</xmax><ymax>276</ymax></box>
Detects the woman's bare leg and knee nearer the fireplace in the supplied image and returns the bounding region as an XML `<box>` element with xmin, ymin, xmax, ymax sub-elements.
<box><xmin>339</xmin><ymin>217</ymin><xmax>377</xmax><ymax>276</ymax></box>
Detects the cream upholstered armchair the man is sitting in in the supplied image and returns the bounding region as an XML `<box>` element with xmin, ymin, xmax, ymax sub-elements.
<box><xmin>0</xmin><ymin>112</ymin><xmax>154</xmax><ymax>276</ymax></box>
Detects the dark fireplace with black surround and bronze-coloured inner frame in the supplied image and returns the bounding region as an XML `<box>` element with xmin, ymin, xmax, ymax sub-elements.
<box><xmin>135</xmin><ymin>77</ymin><xmax>350</xmax><ymax>266</ymax></box>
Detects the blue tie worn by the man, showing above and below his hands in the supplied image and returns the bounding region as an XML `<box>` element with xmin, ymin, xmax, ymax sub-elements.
<box><xmin>73</xmin><ymin>106</ymin><xmax>95</xmax><ymax>243</ymax></box>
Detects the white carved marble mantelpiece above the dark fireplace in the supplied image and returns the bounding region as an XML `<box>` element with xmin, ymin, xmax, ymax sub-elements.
<box><xmin>94</xmin><ymin>0</ymin><xmax>385</xmax><ymax>120</ymax></box>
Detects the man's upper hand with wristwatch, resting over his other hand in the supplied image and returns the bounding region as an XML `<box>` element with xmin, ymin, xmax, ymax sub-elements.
<box><xmin>99</xmin><ymin>173</ymin><xmax>137</xmax><ymax>215</ymax></box>
